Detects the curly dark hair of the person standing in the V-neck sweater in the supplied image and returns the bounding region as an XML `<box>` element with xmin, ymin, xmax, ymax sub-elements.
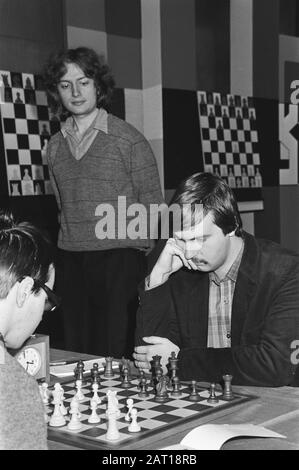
<box><xmin>43</xmin><ymin>47</ymin><xmax>115</xmax><ymax>114</ymax></box>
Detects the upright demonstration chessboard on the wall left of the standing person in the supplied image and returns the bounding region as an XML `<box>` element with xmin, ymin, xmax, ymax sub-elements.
<box><xmin>0</xmin><ymin>71</ymin><xmax>60</xmax><ymax>196</ymax></box>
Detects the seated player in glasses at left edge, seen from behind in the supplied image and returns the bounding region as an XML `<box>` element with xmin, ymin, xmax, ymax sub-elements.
<box><xmin>0</xmin><ymin>214</ymin><xmax>57</xmax><ymax>450</ymax></box>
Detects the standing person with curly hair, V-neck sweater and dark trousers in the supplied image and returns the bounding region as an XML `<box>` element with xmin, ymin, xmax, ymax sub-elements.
<box><xmin>44</xmin><ymin>47</ymin><xmax>163</xmax><ymax>357</ymax></box>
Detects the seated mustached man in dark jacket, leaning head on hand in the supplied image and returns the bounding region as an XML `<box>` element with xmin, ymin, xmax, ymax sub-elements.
<box><xmin>134</xmin><ymin>173</ymin><xmax>299</xmax><ymax>386</ymax></box>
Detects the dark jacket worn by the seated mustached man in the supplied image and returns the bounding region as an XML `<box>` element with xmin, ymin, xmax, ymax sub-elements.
<box><xmin>136</xmin><ymin>232</ymin><xmax>299</xmax><ymax>387</ymax></box>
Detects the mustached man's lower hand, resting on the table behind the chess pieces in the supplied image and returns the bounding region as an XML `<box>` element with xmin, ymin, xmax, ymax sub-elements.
<box><xmin>133</xmin><ymin>336</ymin><xmax>180</xmax><ymax>374</ymax></box>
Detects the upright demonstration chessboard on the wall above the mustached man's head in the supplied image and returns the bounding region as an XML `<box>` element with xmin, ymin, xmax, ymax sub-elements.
<box><xmin>197</xmin><ymin>91</ymin><xmax>262</xmax><ymax>188</ymax></box>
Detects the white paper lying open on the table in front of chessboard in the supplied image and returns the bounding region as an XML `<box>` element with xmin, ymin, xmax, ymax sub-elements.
<box><xmin>163</xmin><ymin>424</ymin><xmax>286</xmax><ymax>450</ymax></box>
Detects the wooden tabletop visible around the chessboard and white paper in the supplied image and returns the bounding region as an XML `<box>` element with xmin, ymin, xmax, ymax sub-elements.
<box><xmin>49</xmin><ymin>349</ymin><xmax>299</xmax><ymax>450</ymax></box>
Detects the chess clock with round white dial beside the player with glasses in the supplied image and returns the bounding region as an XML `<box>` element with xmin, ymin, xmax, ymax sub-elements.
<box><xmin>14</xmin><ymin>334</ymin><xmax>50</xmax><ymax>383</ymax></box>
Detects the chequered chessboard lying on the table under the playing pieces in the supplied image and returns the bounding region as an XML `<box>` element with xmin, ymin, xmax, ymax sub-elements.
<box><xmin>47</xmin><ymin>375</ymin><xmax>255</xmax><ymax>449</ymax></box>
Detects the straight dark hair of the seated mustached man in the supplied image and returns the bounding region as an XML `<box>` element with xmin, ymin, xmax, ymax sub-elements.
<box><xmin>171</xmin><ymin>173</ymin><xmax>242</xmax><ymax>236</ymax></box>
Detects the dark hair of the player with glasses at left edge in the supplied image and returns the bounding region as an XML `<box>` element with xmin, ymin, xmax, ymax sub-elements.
<box><xmin>0</xmin><ymin>212</ymin><xmax>54</xmax><ymax>299</ymax></box>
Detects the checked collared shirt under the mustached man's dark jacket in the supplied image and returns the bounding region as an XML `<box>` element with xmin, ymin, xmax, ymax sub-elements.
<box><xmin>207</xmin><ymin>242</ymin><xmax>244</xmax><ymax>348</ymax></box>
